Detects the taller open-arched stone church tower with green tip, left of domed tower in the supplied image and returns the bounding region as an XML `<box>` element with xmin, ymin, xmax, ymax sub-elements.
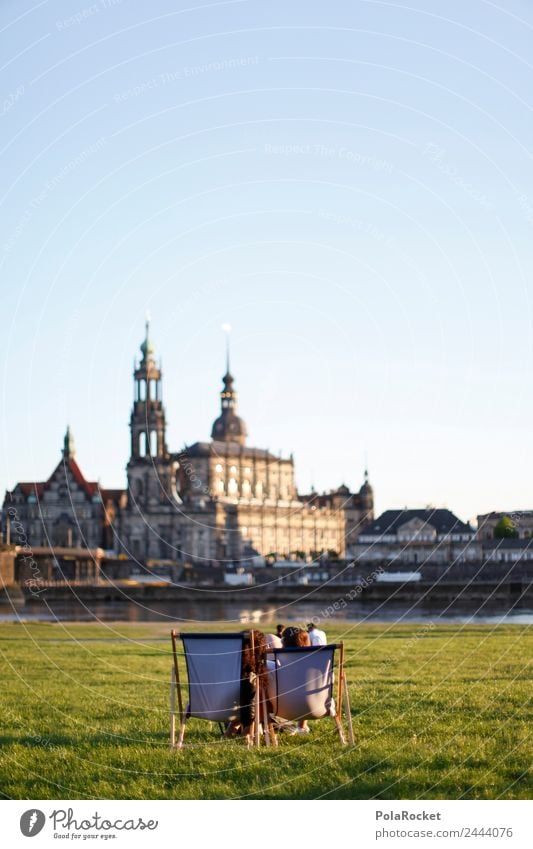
<box><xmin>130</xmin><ymin>321</ymin><xmax>167</xmax><ymax>460</ymax></box>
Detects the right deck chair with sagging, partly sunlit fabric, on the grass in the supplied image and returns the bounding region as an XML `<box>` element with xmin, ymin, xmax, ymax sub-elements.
<box><xmin>270</xmin><ymin>643</ymin><xmax>354</xmax><ymax>746</ymax></box>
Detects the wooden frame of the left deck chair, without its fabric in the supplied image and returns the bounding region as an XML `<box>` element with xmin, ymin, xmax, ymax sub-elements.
<box><xmin>170</xmin><ymin>630</ymin><xmax>268</xmax><ymax>749</ymax></box>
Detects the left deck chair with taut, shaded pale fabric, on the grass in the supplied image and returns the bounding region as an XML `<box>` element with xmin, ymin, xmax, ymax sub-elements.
<box><xmin>170</xmin><ymin>631</ymin><xmax>255</xmax><ymax>749</ymax></box>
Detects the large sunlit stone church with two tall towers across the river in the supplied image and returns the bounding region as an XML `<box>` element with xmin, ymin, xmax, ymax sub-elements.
<box><xmin>119</xmin><ymin>325</ymin><xmax>373</xmax><ymax>562</ymax></box>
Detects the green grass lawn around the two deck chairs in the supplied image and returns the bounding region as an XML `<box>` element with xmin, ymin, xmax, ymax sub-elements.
<box><xmin>0</xmin><ymin>623</ymin><xmax>533</xmax><ymax>799</ymax></box>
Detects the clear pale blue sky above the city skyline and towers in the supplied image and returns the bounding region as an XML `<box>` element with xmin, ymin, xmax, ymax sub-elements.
<box><xmin>0</xmin><ymin>0</ymin><xmax>533</xmax><ymax>519</ymax></box>
